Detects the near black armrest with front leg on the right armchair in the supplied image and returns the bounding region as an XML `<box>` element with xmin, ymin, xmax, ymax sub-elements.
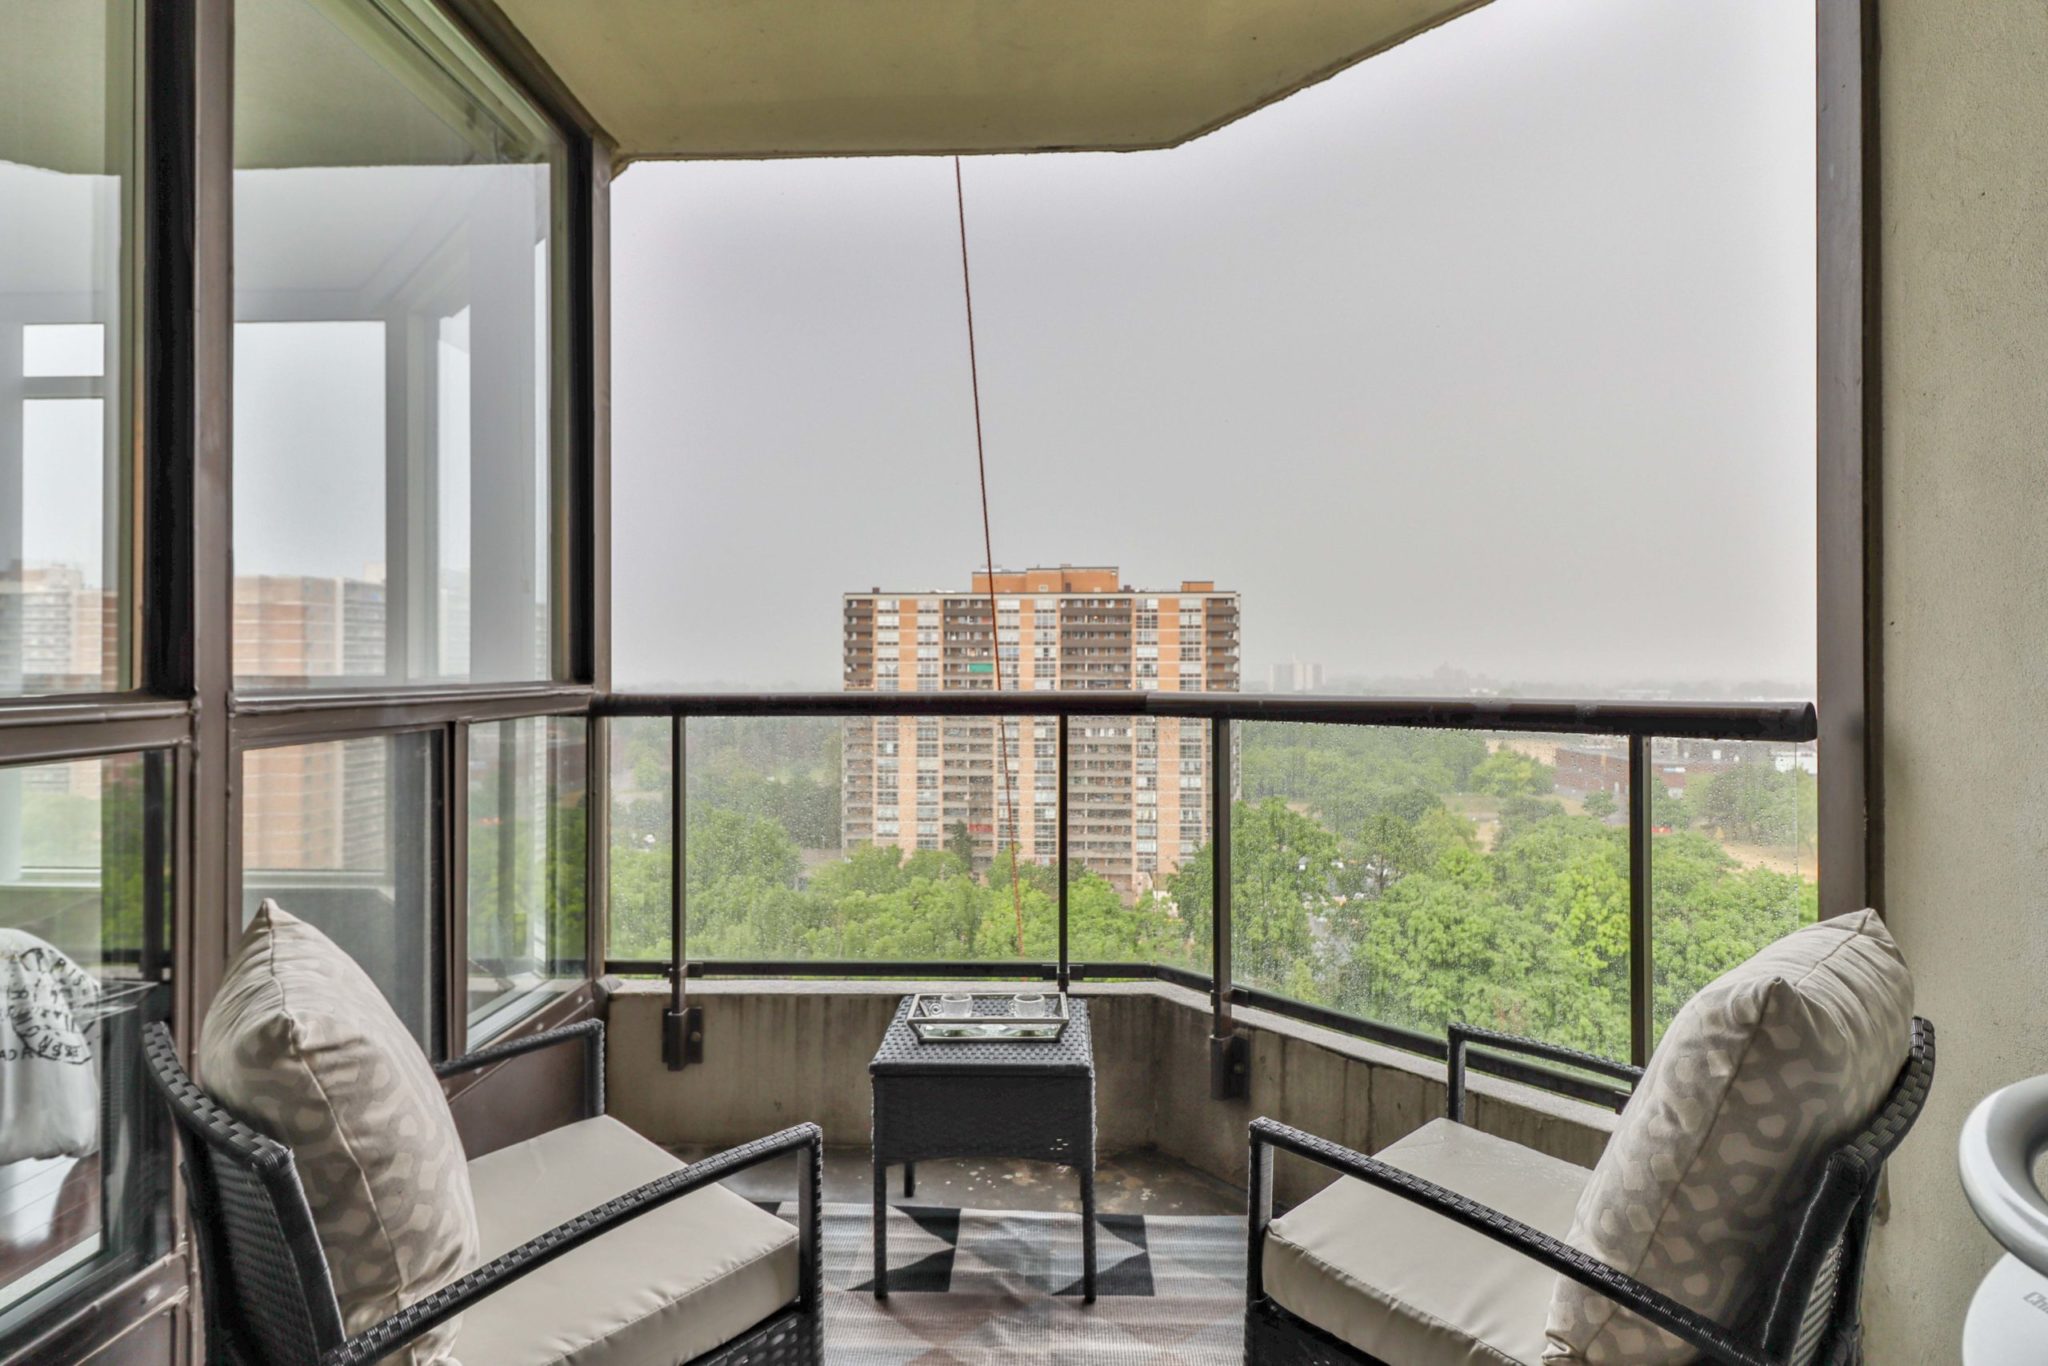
<box><xmin>1245</xmin><ymin>1118</ymin><xmax>1780</xmax><ymax>1366</ymax></box>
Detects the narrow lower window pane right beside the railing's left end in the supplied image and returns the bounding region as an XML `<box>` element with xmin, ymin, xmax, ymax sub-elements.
<box><xmin>469</xmin><ymin>717</ymin><xmax>590</xmax><ymax>1047</ymax></box>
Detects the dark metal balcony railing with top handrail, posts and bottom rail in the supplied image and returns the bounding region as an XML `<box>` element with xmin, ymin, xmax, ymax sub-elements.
<box><xmin>590</xmin><ymin>688</ymin><xmax>1819</xmax><ymax>1106</ymax></box>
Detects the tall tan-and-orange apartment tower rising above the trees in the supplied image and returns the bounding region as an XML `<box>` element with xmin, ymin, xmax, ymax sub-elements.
<box><xmin>840</xmin><ymin>565</ymin><xmax>1239</xmax><ymax>895</ymax></box>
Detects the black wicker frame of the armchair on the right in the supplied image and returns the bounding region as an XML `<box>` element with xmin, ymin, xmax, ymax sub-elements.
<box><xmin>1245</xmin><ymin>1020</ymin><xmax>1933</xmax><ymax>1366</ymax></box>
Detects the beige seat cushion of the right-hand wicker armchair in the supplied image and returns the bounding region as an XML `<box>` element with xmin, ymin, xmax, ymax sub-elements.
<box><xmin>1266</xmin><ymin>1120</ymin><xmax>1591</xmax><ymax>1366</ymax></box>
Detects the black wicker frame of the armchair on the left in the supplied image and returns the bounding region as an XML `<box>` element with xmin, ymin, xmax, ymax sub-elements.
<box><xmin>143</xmin><ymin>1020</ymin><xmax>825</xmax><ymax>1366</ymax></box>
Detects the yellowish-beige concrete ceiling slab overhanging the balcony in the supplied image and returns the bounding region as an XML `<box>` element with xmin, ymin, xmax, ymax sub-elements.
<box><xmin>496</xmin><ymin>0</ymin><xmax>1485</xmax><ymax>160</ymax></box>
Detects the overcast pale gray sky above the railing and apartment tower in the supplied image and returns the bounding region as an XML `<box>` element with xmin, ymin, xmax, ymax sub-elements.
<box><xmin>612</xmin><ymin>0</ymin><xmax>1815</xmax><ymax>688</ymax></box>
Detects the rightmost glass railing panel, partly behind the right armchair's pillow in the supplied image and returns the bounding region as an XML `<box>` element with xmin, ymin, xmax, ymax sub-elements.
<box><xmin>1651</xmin><ymin>739</ymin><xmax>1821</xmax><ymax>1038</ymax></box>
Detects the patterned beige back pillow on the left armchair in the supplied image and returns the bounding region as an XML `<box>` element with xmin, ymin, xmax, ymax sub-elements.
<box><xmin>199</xmin><ymin>901</ymin><xmax>477</xmax><ymax>1366</ymax></box>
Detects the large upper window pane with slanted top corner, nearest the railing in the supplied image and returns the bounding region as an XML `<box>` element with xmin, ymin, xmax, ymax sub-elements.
<box><xmin>236</xmin><ymin>0</ymin><xmax>563</xmax><ymax>688</ymax></box>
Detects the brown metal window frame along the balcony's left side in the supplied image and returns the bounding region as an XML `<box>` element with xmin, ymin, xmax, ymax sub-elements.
<box><xmin>0</xmin><ymin>0</ymin><xmax>610</xmax><ymax>1360</ymax></box>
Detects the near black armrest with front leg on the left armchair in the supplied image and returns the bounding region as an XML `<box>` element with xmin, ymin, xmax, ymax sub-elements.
<box><xmin>322</xmin><ymin>1122</ymin><xmax>825</xmax><ymax>1366</ymax></box>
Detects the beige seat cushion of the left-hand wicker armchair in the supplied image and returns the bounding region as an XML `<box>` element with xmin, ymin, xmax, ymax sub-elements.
<box><xmin>455</xmin><ymin>1118</ymin><xmax>797</xmax><ymax>1366</ymax></box>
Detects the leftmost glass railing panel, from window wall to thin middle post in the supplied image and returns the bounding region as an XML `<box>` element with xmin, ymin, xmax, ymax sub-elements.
<box><xmin>610</xmin><ymin>717</ymin><xmax>1059</xmax><ymax>969</ymax></box>
